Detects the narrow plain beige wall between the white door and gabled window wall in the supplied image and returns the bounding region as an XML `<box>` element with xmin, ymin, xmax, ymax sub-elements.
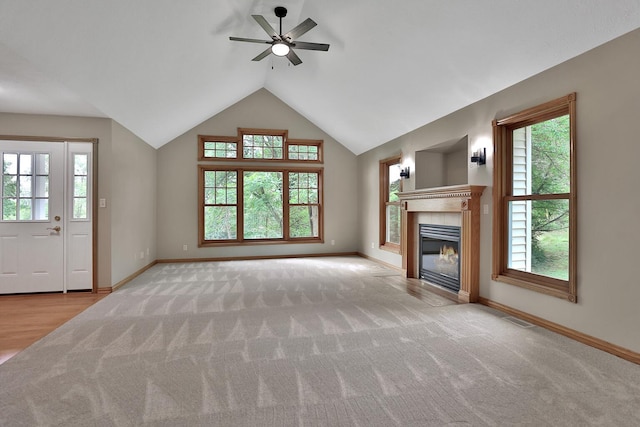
<box><xmin>110</xmin><ymin>122</ymin><xmax>157</xmax><ymax>284</ymax></box>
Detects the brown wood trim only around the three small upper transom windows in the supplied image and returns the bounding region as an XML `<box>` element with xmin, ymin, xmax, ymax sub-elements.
<box><xmin>198</xmin><ymin>128</ymin><xmax>324</xmax><ymax>164</ymax></box>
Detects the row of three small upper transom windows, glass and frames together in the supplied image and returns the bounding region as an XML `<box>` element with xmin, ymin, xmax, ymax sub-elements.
<box><xmin>198</xmin><ymin>128</ymin><xmax>322</xmax><ymax>163</ymax></box>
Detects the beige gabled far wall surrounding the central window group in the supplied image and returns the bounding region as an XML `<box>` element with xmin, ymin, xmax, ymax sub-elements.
<box><xmin>152</xmin><ymin>89</ymin><xmax>358</xmax><ymax>259</ymax></box>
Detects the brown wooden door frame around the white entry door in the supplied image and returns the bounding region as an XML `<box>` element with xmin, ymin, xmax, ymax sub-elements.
<box><xmin>0</xmin><ymin>135</ymin><xmax>98</xmax><ymax>294</ymax></box>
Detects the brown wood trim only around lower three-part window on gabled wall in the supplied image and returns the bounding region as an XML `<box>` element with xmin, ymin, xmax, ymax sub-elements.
<box><xmin>198</xmin><ymin>166</ymin><xmax>324</xmax><ymax>247</ymax></box>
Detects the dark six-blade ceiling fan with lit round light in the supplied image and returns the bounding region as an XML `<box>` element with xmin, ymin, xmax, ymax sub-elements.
<box><xmin>229</xmin><ymin>6</ymin><xmax>329</xmax><ymax>65</ymax></box>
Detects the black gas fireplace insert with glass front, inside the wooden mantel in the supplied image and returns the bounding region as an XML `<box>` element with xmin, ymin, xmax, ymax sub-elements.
<box><xmin>419</xmin><ymin>224</ymin><xmax>460</xmax><ymax>293</ymax></box>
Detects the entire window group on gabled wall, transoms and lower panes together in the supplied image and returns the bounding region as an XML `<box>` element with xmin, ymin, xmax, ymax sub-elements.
<box><xmin>198</xmin><ymin>128</ymin><xmax>323</xmax><ymax>246</ymax></box>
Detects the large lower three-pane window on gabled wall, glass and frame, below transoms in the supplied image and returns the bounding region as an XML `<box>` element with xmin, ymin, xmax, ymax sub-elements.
<box><xmin>199</xmin><ymin>165</ymin><xmax>322</xmax><ymax>246</ymax></box>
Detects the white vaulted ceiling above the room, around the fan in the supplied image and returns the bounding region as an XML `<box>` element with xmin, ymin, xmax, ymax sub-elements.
<box><xmin>0</xmin><ymin>0</ymin><xmax>640</xmax><ymax>154</ymax></box>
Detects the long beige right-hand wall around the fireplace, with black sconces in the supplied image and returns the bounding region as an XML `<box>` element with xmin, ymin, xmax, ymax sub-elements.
<box><xmin>358</xmin><ymin>30</ymin><xmax>640</xmax><ymax>352</ymax></box>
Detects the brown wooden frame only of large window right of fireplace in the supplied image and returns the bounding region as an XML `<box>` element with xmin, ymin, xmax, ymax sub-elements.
<box><xmin>491</xmin><ymin>93</ymin><xmax>578</xmax><ymax>303</ymax></box>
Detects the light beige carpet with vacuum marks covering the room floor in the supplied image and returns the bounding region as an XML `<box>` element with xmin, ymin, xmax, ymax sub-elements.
<box><xmin>0</xmin><ymin>257</ymin><xmax>640</xmax><ymax>426</ymax></box>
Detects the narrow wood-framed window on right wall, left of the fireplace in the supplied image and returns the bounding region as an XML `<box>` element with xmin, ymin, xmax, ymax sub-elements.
<box><xmin>380</xmin><ymin>156</ymin><xmax>402</xmax><ymax>253</ymax></box>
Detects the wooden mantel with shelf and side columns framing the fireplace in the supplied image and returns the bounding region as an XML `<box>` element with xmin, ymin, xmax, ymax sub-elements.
<box><xmin>400</xmin><ymin>185</ymin><xmax>485</xmax><ymax>302</ymax></box>
